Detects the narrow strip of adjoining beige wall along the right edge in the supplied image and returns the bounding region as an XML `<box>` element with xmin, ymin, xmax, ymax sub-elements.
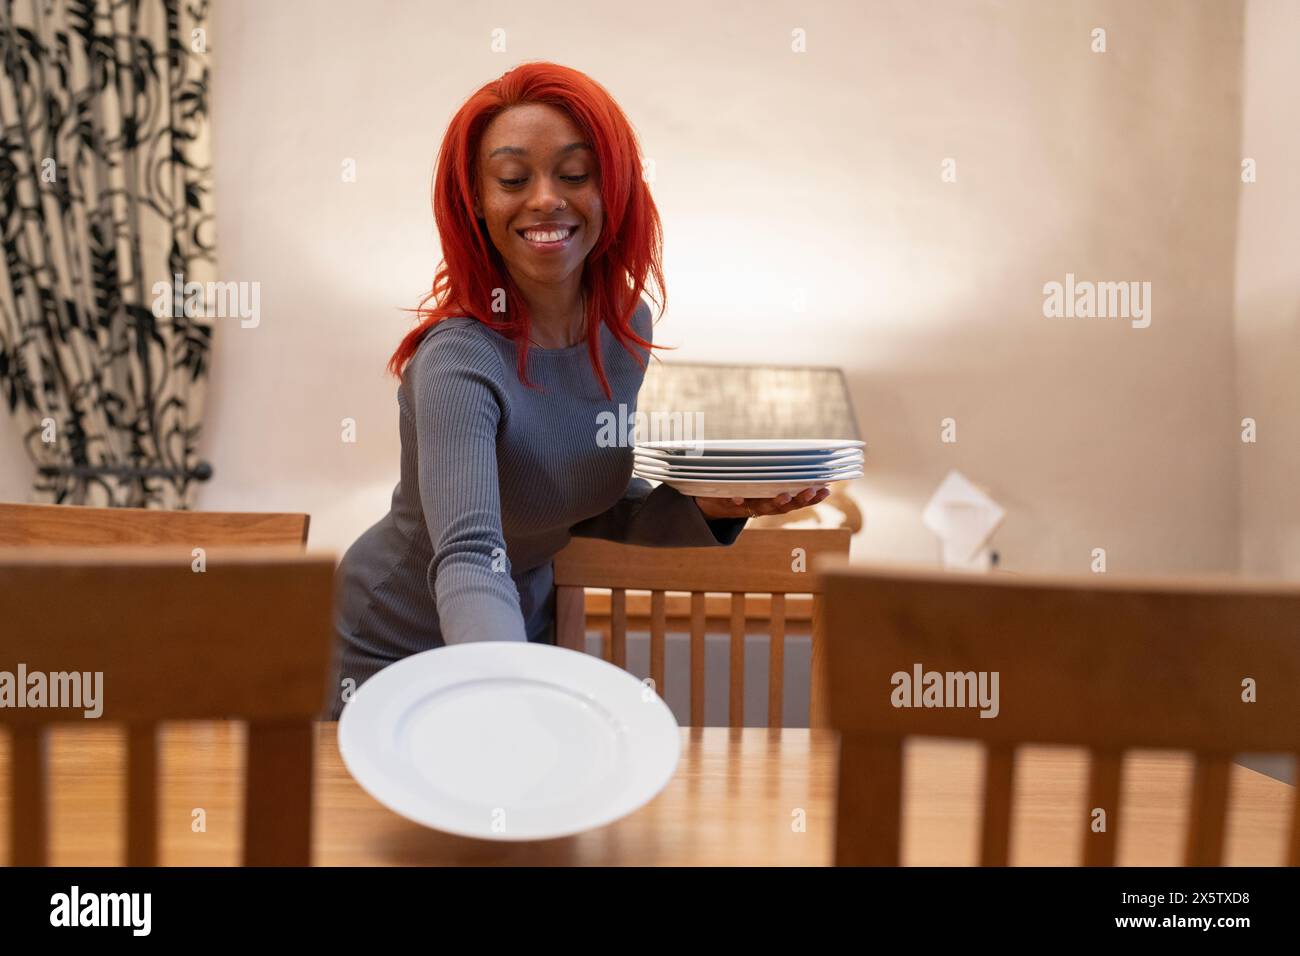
<box><xmin>1235</xmin><ymin>0</ymin><xmax>1300</xmax><ymax>578</ymax></box>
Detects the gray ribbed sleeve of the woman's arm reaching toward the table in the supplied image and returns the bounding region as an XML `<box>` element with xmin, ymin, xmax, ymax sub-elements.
<box><xmin>412</xmin><ymin>329</ymin><xmax>527</xmax><ymax>644</ymax></box>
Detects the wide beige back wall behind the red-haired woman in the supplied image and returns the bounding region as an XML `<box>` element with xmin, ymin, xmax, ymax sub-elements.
<box><xmin>0</xmin><ymin>0</ymin><xmax>1268</xmax><ymax>572</ymax></box>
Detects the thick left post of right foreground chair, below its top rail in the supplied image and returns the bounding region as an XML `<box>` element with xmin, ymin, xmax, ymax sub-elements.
<box><xmin>835</xmin><ymin>732</ymin><xmax>902</xmax><ymax>866</ymax></box>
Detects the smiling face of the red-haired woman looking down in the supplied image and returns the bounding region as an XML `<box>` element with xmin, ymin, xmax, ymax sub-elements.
<box><xmin>475</xmin><ymin>103</ymin><xmax>603</xmax><ymax>285</ymax></box>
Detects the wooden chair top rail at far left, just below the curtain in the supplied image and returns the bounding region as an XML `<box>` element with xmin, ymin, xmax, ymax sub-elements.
<box><xmin>0</xmin><ymin>502</ymin><xmax>311</xmax><ymax>548</ymax></box>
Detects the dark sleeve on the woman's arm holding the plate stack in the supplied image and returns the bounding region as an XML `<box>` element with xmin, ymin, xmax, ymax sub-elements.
<box><xmin>569</xmin><ymin>477</ymin><xmax>749</xmax><ymax>548</ymax></box>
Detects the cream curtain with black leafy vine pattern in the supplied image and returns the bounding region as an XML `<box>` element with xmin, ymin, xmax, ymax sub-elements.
<box><xmin>0</xmin><ymin>0</ymin><xmax>216</xmax><ymax>509</ymax></box>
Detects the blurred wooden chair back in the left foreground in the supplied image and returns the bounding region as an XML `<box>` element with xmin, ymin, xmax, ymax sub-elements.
<box><xmin>0</xmin><ymin>541</ymin><xmax>334</xmax><ymax>866</ymax></box>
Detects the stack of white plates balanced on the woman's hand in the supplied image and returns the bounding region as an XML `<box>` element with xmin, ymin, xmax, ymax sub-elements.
<box><xmin>633</xmin><ymin>438</ymin><xmax>863</xmax><ymax>498</ymax></box>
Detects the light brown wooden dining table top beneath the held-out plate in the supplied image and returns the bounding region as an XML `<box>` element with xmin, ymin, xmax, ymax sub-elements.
<box><xmin>0</xmin><ymin>722</ymin><xmax>1292</xmax><ymax>866</ymax></box>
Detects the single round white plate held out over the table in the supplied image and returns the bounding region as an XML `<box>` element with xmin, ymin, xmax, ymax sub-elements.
<box><xmin>338</xmin><ymin>641</ymin><xmax>681</xmax><ymax>840</ymax></box>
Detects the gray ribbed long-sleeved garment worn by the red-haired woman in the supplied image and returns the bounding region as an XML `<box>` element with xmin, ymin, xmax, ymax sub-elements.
<box><xmin>325</xmin><ymin>302</ymin><xmax>745</xmax><ymax>719</ymax></box>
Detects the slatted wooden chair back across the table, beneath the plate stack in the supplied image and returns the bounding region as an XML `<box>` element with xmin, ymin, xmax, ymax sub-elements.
<box><xmin>555</xmin><ymin>528</ymin><xmax>852</xmax><ymax>727</ymax></box>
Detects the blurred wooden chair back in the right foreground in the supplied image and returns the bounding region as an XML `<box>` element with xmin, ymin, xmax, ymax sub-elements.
<box><xmin>815</xmin><ymin>561</ymin><xmax>1300</xmax><ymax>866</ymax></box>
